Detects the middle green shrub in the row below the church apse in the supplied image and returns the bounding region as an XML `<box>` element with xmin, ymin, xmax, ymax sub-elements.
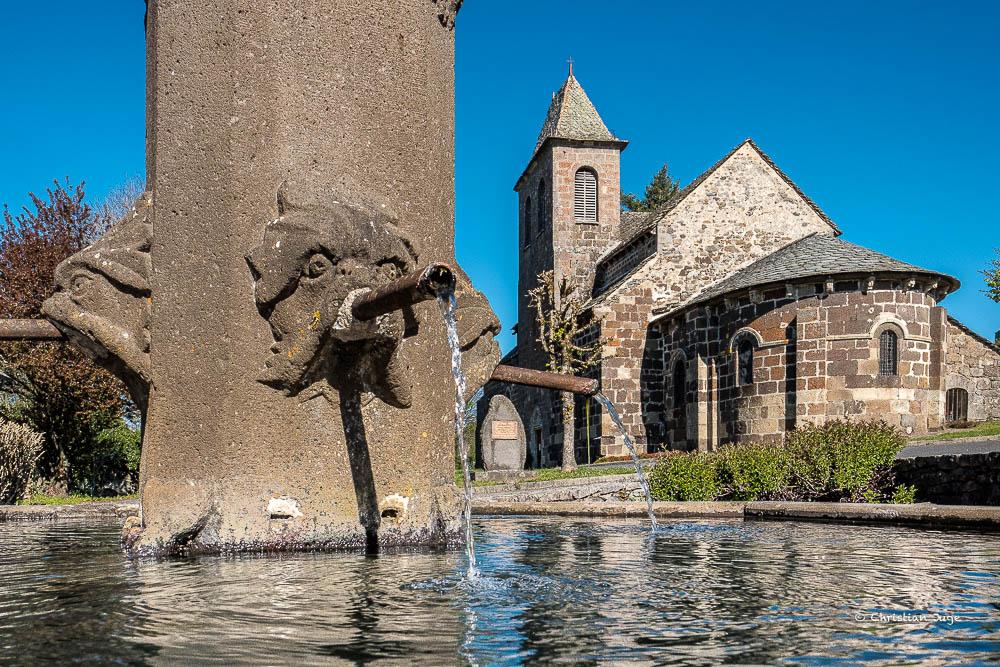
<box><xmin>719</xmin><ymin>443</ymin><xmax>791</xmax><ymax>500</ymax></box>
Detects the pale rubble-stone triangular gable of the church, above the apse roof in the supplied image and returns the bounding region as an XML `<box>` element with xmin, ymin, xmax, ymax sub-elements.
<box><xmin>656</xmin><ymin>140</ymin><xmax>840</xmax><ymax>305</ymax></box>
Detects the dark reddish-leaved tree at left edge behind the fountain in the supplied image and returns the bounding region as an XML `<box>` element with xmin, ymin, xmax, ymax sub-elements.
<box><xmin>0</xmin><ymin>181</ymin><xmax>126</xmax><ymax>488</ymax></box>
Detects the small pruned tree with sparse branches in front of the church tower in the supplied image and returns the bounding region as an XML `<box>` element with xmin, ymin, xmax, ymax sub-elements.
<box><xmin>528</xmin><ymin>271</ymin><xmax>604</xmax><ymax>471</ymax></box>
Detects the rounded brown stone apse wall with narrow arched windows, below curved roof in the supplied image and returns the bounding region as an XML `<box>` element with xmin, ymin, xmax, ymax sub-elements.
<box><xmin>644</xmin><ymin>280</ymin><xmax>945</xmax><ymax>450</ymax></box>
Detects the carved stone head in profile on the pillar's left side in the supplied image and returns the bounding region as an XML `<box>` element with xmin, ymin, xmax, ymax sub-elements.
<box><xmin>42</xmin><ymin>192</ymin><xmax>153</xmax><ymax>413</ymax></box>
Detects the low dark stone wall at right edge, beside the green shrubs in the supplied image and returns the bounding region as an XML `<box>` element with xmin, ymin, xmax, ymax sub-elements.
<box><xmin>895</xmin><ymin>452</ymin><xmax>1000</xmax><ymax>505</ymax></box>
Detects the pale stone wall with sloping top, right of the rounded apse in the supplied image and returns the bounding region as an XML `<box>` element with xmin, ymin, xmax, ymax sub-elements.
<box><xmin>945</xmin><ymin>320</ymin><xmax>1000</xmax><ymax>421</ymax></box>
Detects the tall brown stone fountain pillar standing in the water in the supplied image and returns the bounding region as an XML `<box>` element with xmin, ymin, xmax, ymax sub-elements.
<box><xmin>48</xmin><ymin>0</ymin><xmax>498</xmax><ymax>553</ymax></box>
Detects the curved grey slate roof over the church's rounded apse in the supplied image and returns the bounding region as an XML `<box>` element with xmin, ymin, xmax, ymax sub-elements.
<box><xmin>656</xmin><ymin>234</ymin><xmax>959</xmax><ymax>312</ymax></box>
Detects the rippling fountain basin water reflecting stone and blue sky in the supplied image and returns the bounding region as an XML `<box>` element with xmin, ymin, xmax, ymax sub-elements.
<box><xmin>0</xmin><ymin>517</ymin><xmax>1000</xmax><ymax>664</ymax></box>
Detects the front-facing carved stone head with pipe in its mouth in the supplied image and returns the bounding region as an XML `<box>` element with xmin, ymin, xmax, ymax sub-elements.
<box><xmin>247</xmin><ymin>186</ymin><xmax>417</xmax><ymax>407</ymax></box>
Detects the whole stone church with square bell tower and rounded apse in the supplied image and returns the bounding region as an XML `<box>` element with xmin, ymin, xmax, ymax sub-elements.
<box><xmin>479</xmin><ymin>72</ymin><xmax>1000</xmax><ymax>467</ymax></box>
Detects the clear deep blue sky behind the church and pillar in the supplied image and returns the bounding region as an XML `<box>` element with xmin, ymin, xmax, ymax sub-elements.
<box><xmin>0</xmin><ymin>0</ymin><xmax>1000</xmax><ymax>350</ymax></box>
